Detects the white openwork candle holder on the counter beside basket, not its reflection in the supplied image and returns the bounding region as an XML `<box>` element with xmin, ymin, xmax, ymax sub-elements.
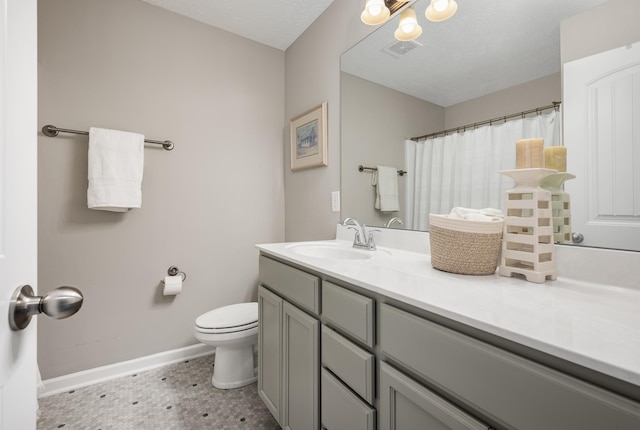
<box><xmin>499</xmin><ymin>168</ymin><xmax>558</xmax><ymax>284</ymax></box>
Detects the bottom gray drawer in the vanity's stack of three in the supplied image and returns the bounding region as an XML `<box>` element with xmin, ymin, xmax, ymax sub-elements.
<box><xmin>321</xmin><ymin>368</ymin><xmax>376</xmax><ymax>430</ymax></box>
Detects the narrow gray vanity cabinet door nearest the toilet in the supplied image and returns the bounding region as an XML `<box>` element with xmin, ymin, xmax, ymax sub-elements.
<box><xmin>258</xmin><ymin>286</ymin><xmax>283</xmax><ymax>423</ymax></box>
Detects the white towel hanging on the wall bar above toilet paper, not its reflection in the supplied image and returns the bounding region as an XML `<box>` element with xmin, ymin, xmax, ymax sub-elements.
<box><xmin>87</xmin><ymin>127</ymin><xmax>144</xmax><ymax>212</ymax></box>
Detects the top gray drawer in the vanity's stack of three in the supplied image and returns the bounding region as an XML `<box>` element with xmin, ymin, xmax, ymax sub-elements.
<box><xmin>322</xmin><ymin>282</ymin><xmax>375</xmax><ymax>347</ymax></box>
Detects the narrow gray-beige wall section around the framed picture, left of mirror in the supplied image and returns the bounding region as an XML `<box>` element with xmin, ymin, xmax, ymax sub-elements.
<box><xmin>284</xmin><ymin>0</ymin><xmax>375</xmax><ymax>241</ymax></box>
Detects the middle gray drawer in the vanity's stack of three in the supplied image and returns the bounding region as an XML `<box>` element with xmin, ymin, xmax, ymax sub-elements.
<box><xmin>322</xmin><ymin>325</ymin><xmax>375</xmax><ymax>403</ymax></box>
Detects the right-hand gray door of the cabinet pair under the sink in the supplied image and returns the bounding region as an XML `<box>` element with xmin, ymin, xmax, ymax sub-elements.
<box><xmin>280</xmin><ymin>301</ymin><xmax>320</xmax><ymax>430</ymax></box>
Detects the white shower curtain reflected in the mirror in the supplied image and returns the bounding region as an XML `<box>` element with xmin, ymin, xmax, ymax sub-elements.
<box><xmin>405</xmin><ymin>110</ymin><xmax>562</xmax><ymax>230</ymax></box>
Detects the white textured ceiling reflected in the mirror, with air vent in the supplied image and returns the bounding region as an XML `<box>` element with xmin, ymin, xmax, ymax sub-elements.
<box><xmin>341</xmin><ymin>0</ymin><xmax>605</xmax><ymax>107</ymax></box>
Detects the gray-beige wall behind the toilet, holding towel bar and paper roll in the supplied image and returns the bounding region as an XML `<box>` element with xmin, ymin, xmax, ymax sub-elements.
<box><xmin>38</xmin><ymin>0</ymin><xmax>282</xmax><ymax>378</ymax></box>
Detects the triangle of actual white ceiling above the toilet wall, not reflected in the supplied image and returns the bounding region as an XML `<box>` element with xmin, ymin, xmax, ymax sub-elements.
<box><xmin>142</xmin><ymin>0</ymin><xmax>336</xmax><ymax>51</ymax></box>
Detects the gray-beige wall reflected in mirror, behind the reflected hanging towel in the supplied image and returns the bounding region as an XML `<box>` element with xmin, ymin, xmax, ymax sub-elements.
<box><xmin>340</xmin><ymin>73</ymin><xmax>445</xmax><ymax>226</ymax></box>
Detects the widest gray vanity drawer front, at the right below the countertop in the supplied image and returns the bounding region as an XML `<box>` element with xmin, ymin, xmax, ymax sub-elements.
<box><xmin>380</xmin><ymin>304</ymin><xmax>640</xmax><ymax>430</ymax></box>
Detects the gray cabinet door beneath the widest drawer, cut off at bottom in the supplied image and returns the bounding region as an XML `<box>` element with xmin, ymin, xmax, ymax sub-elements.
<box><xmin>379</xmin><ymin>362</ymin><xmax>488</xmax><ymax>430</ymax></box>
